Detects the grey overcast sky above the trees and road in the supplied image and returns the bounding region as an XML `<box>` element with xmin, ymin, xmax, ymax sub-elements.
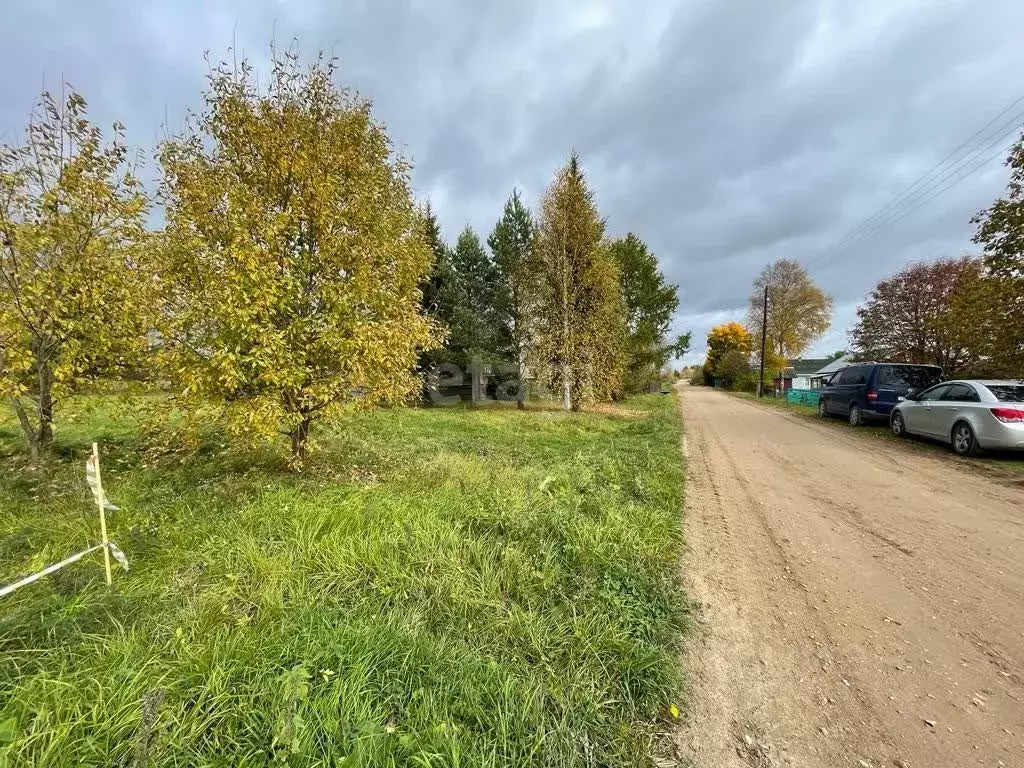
<box><xmin>0</xmin><ymin>0</ymin><xmax>1024</xmax><ymax>361</ymax></box>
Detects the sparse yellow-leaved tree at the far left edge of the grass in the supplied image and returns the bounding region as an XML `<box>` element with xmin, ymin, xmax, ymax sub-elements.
<box><xmin>0</xmin><ymin>86</ymin><xmax>152</xmax><ymax>457</ymax></box>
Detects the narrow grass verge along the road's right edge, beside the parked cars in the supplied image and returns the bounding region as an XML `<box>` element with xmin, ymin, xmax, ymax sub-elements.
<box><xmin>729</xmin><ymin>392</ymin><xmax>1024</xmax><ymax>483</ymax></box>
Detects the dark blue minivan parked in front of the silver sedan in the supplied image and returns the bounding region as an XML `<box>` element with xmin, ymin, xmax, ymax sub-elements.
<box><xmin>818</xmin><ymin>362</ymin><xmax>942</xmax><ymax>427</ymax></box>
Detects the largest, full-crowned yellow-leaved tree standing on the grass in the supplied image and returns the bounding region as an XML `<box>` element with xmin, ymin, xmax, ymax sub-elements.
<box><xmin>159</xmin><ymin>49</ymin><xmax>434</xmax><ymax>465</ymax></box>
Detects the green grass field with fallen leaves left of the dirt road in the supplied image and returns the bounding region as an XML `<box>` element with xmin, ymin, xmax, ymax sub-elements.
<box><xmin>0</xmin><ymin>394</ymin><xmax>688</xmax><ymax>768</ymax></box>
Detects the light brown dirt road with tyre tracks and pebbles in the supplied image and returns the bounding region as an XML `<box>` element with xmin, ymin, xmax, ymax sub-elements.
<box><xmin>680</xmin><ymin>386</ymin><xmax>1024</xmax><ymax>768</ymax></box>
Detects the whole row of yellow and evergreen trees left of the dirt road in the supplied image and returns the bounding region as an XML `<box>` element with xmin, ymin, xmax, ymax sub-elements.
<box><xmin>0</xmin><ymin>47</ymin><xmax>689</xmax><ymax>467</ymax></box>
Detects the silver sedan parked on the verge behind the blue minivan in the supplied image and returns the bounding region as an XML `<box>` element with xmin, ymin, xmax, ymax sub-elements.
<box><xmin>889</xmin><ymin>379</ymin><xmax>1024</xmax><ymax>456</ymax></box>
